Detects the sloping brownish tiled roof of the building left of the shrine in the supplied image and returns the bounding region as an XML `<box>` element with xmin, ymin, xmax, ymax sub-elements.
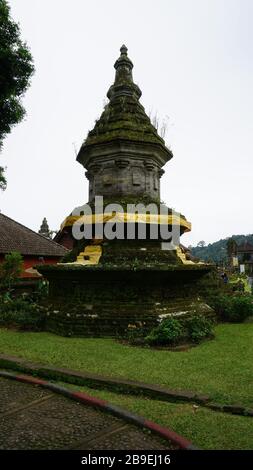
<box><xmin>0</xmin><ymin>213</ymin><xmax>68</xmax><ymax>258</ymax></box>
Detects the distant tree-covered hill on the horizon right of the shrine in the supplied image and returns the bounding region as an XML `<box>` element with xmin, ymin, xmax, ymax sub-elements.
<box><xmin>189</xmin><ymin>234</ymin><xmax>253</xmax><ymax>263</ymax></box>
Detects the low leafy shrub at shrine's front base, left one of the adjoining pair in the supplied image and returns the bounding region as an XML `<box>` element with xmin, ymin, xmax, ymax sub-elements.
<box><xmin>146</xmin><ymin>317</ymin><xmax>185</xmax><ymax>346</ymax></box>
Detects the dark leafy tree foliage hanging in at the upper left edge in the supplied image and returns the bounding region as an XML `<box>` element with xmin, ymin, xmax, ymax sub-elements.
<box><xmin>0</xmin><ymin>0</ymin><xmax>34</xmax><ymax>189</ymax></box>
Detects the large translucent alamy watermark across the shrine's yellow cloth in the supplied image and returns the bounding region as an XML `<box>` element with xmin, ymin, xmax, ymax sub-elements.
<box><xmin>72</xmin><ymin>196</ymin><xmax>180</xmax><ymax>250</ymax></box>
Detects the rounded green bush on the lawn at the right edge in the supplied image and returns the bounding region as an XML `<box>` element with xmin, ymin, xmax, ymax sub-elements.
<box><xmin>210</xmin><ymin>293</ymin><xmax>253</xmax><ymax>323</ymax></box>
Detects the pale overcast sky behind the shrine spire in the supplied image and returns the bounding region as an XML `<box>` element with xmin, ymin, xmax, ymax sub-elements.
<box><xmin>0</xmin><ymin>0</ymin><xmax>253</xmax><ymax>245</ymax></box>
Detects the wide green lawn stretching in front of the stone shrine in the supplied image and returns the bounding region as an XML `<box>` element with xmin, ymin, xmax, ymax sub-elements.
<box><xmin>0</xmin><ymin>323</ymin><xmax>253</xmax><ymax>407</ymax></box>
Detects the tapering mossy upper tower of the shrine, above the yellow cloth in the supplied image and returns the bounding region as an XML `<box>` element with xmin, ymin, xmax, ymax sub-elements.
<box><xmin>77</xmin><ymin>45</ymin><xmax>173</xmax><ymax>202</ymax></box>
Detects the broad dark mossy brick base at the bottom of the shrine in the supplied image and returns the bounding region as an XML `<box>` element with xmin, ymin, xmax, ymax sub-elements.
<box><xmin>37</xmin><ymin>265</ymin><xmax>216</xmax><ymax>337</ymax></box>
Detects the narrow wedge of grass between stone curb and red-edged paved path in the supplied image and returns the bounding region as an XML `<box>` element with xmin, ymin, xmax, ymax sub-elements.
<box><xmin>55</xmin><ymin>383</ymin><xmax>253</xmax><ymax>450</ymax></box>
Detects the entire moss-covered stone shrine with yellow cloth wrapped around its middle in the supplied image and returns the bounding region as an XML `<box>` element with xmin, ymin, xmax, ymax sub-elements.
<box><xmin>38</xmin><ymin>46</ymin><xmax>215</xmax><ymax>336</ymax></box>
